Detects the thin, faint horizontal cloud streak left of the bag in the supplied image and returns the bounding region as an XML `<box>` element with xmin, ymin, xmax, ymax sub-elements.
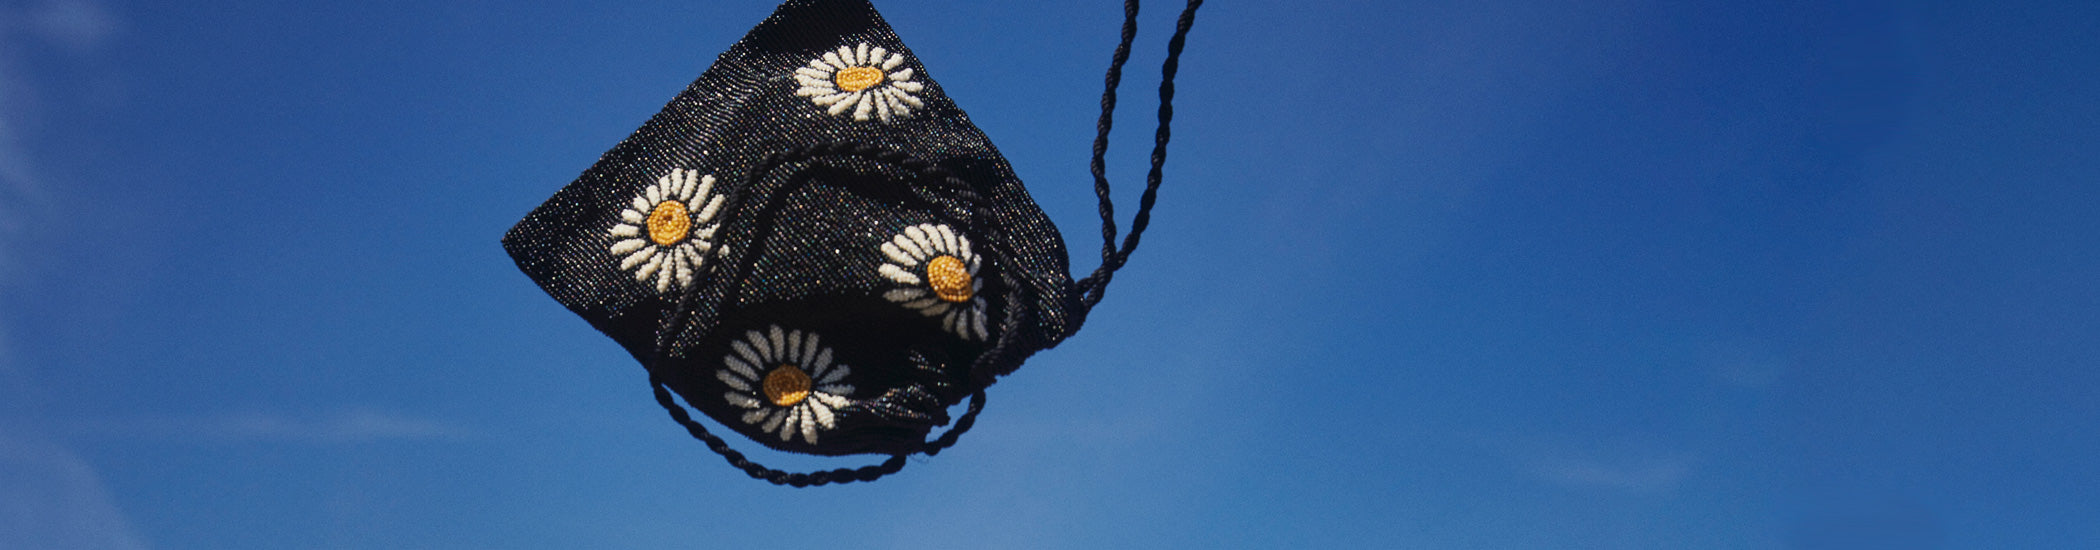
<box><xmin>63</xmin><ymin>409</ymin><xmax>468</xmax><ymax>445</ymax></box>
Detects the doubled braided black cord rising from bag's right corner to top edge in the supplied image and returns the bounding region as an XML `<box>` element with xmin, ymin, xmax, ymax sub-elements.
<box><xmin>1073</xmin><ymin>0</ymin><xmax>1203</xmax><ymax>309</ymax></box>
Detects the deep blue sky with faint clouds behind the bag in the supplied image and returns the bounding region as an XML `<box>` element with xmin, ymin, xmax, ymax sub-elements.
<box><xmin>0</xmin><ymin>0</ymin><xmax>2100</xmax><ymax>548</ymax></box>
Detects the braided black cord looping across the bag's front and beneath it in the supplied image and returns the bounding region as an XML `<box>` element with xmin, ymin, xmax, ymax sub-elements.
<box><xmin>649</xmin><ymin>143</ymin><xmax>1027</xmax><ymax>487</ymax></box>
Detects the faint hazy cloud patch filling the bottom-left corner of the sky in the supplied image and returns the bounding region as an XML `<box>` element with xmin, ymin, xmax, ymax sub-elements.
<box><xmin>0</xmin><ymin>430</ymin><xmax>147</xmax><ymax>550</ymax></box>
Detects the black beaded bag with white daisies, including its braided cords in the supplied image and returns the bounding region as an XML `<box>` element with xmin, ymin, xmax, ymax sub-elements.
<box><xmin>504</xmin><ymin>0</ymin><xmax>1201</xmax><ymax>487</ymax></box>
